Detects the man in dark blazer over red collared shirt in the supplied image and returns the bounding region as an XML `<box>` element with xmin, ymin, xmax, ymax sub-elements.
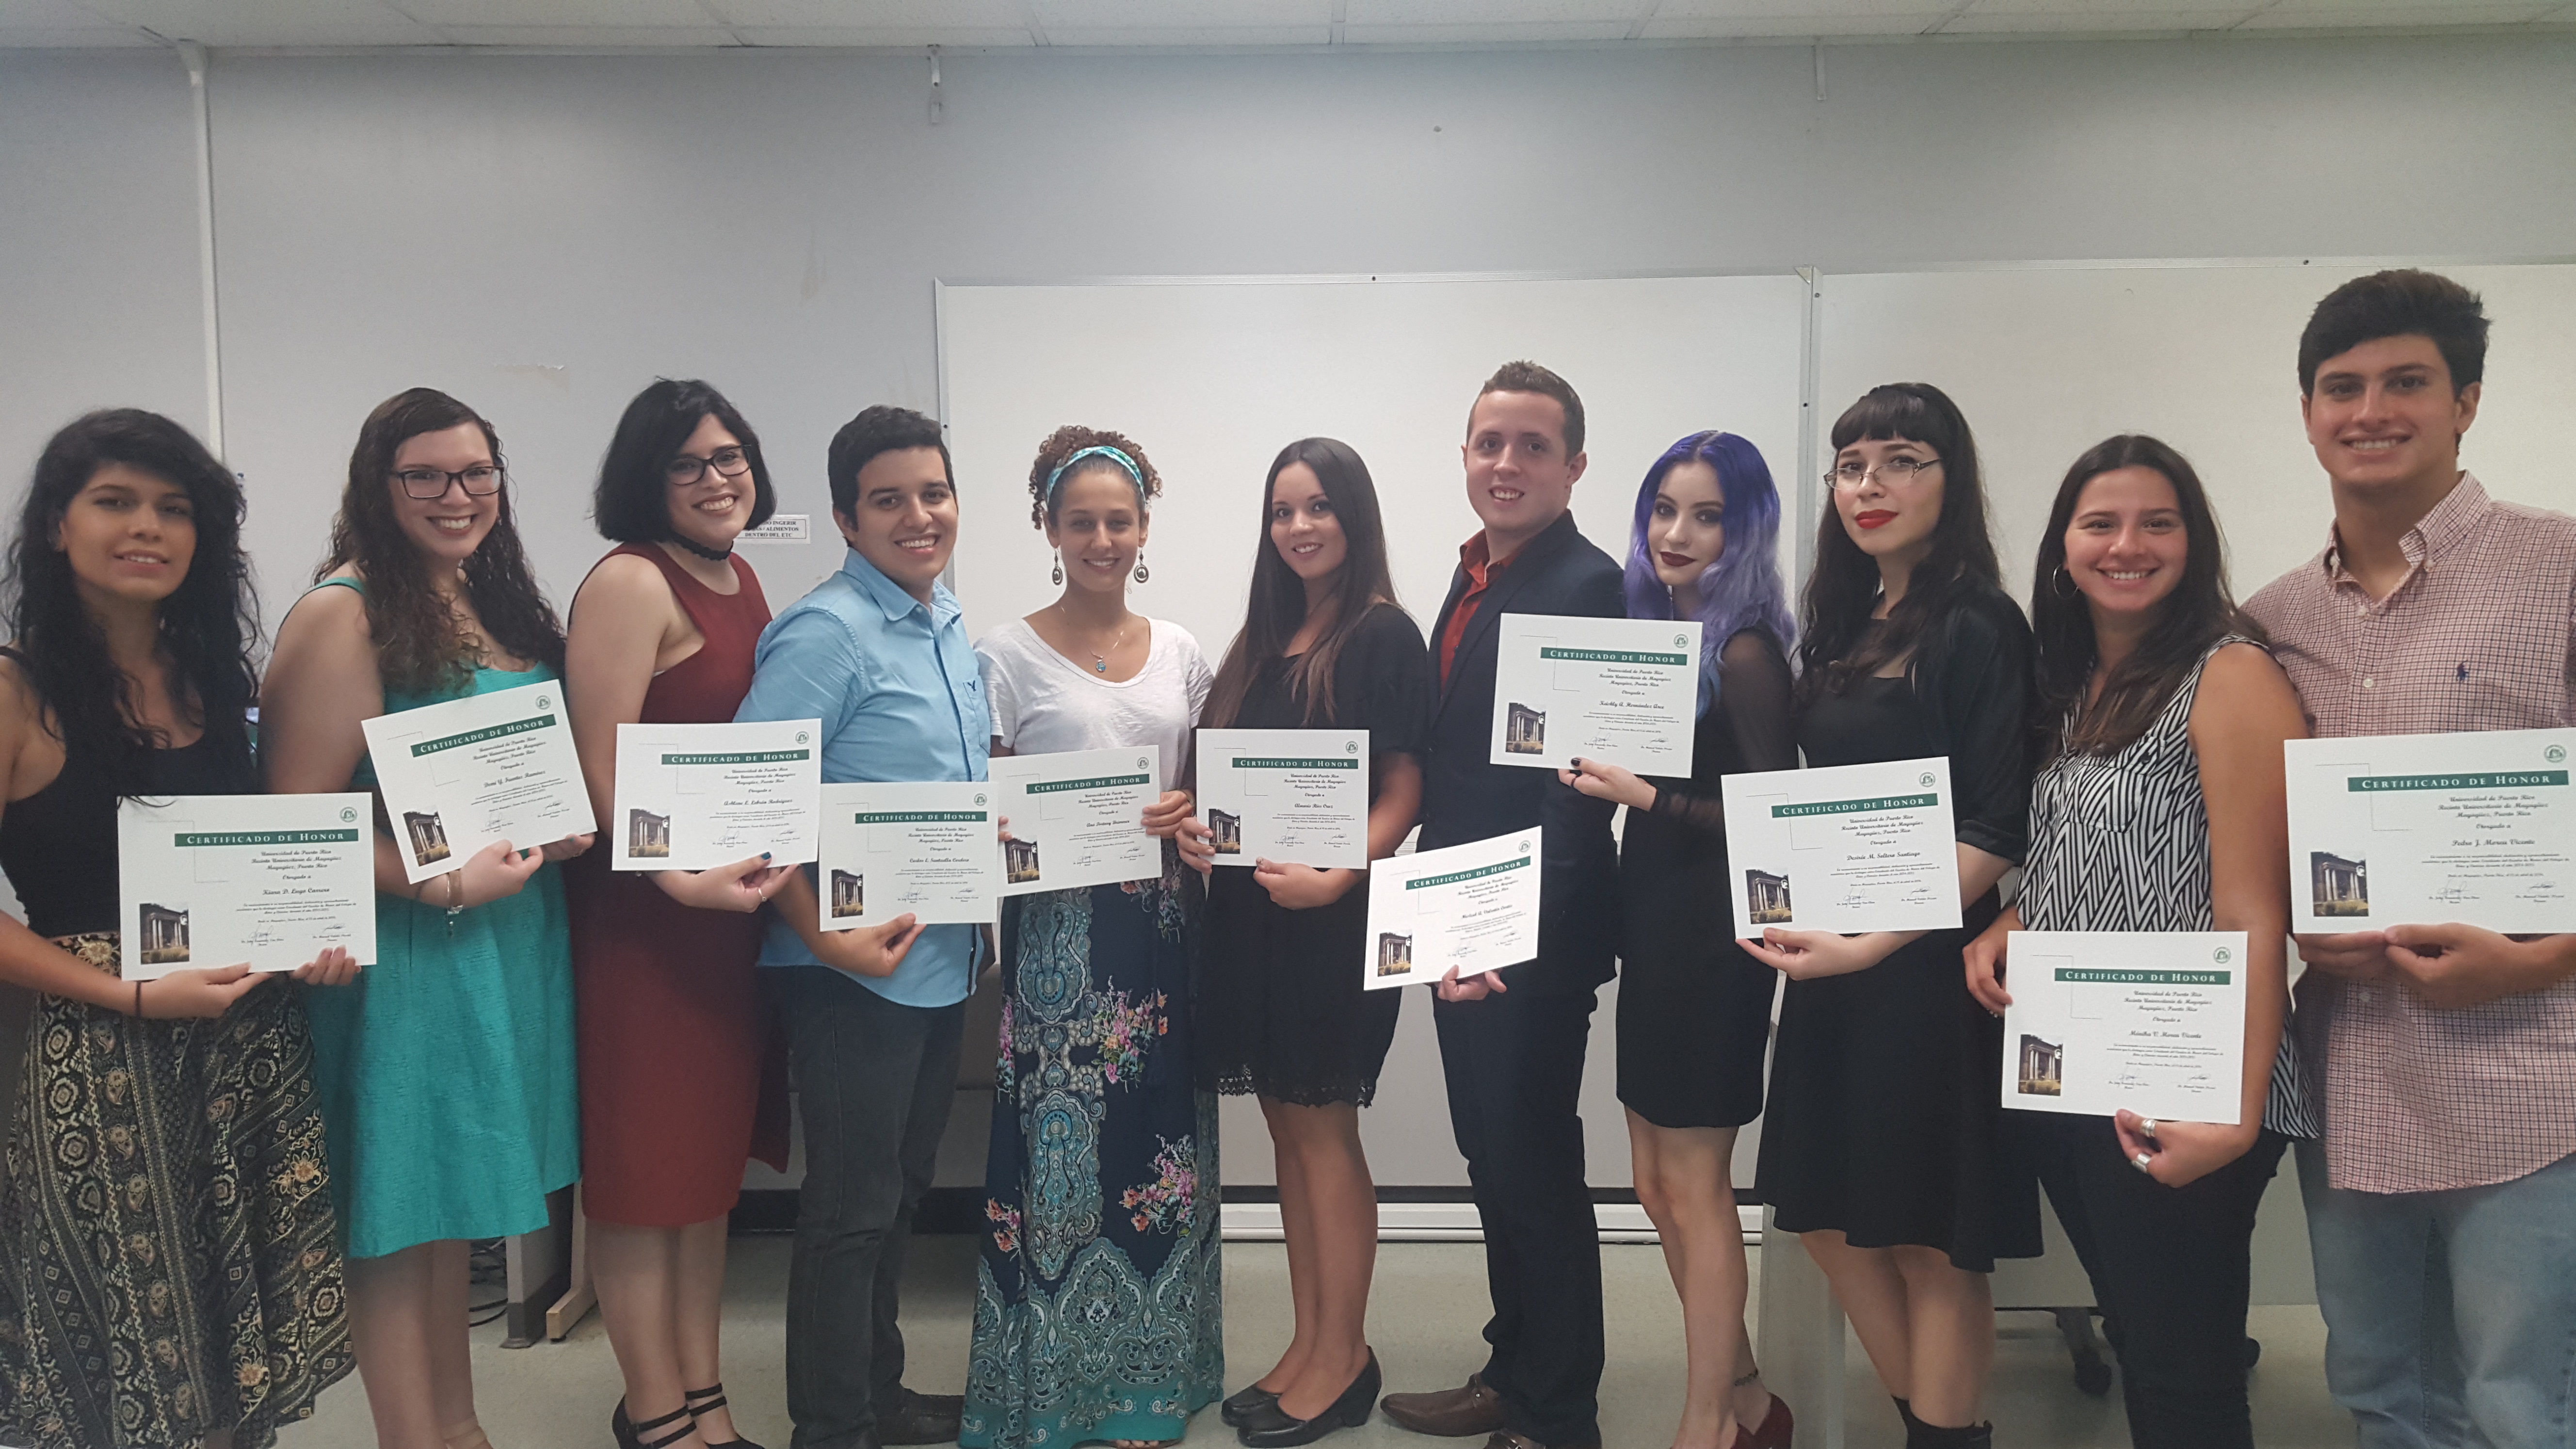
<box><xmin>1384</xmin><ymin>364</ymin><xmax>1628</xmax><ymax>1449</ymax></box>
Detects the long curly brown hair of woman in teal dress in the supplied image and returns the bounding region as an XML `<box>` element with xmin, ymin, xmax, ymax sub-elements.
<box><xmin>314</xmin><ymin>387</ymin><xmax>564</xmax><ymax>693</ymax></box>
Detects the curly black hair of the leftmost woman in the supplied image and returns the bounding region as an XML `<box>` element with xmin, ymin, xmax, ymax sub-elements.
<box><xmin>5</xmin><ymin>407</ymin><xmax>260</xmax><ymax>794</ymax></box>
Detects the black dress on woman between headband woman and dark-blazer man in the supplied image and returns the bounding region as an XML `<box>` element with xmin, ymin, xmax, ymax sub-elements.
<box><xmin>1198</xmin><ymin>603</ymin><xmax>1432</xmax><ymax>1106</ymax></box>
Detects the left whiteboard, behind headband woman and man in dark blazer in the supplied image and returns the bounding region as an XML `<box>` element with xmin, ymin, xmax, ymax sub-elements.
<box><xmin>940</xmin><ymin>274</ymin><xmax>1806</xmax><ymax>668</ymax></box>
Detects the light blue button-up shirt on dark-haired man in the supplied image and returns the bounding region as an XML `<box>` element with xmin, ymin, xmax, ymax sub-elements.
<box><xmin>734</xmin><ymin>549</ymin><xmax>992</xmax><ymax>1006</ymax></box>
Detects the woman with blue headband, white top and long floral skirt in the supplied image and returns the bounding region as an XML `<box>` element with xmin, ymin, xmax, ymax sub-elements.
<box><xmin>958</xmin><ymin>428</ymin><xmax>1226</xmax><ymax>1449</ymax></box>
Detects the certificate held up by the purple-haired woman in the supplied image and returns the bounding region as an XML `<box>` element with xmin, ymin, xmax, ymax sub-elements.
<box><xmin>1492</xmin><ymin>613</ymin><xmax>1700</xmax><ymax>779</ymax></box>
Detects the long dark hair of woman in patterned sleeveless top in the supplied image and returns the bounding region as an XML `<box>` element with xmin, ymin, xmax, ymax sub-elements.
<box><xmin>2030</xmin><ymin>433</ymin><xmax>2264</xmax><ymax>763</ymax></box>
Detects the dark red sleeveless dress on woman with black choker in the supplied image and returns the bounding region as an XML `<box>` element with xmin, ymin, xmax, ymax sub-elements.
<box><xmin>564</xmin><ymin>544</ymin><xmax>788</xmax><ymax>1227</ymax></box>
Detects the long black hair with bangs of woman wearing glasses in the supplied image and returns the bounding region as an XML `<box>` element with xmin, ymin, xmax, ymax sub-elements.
<box><xmin>1798</xmin><ymin>382</ymin><xmax>2004</xmax><ymax>701</ymax></box>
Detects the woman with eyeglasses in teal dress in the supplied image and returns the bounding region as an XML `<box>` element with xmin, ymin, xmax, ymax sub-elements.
<box><xmin>260</xmin><ymin>387</ymin><xmax>590</xmax><ymax>1449</ymax></box>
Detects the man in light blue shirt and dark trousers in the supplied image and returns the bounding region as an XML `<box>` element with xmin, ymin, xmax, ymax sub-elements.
<box><xmin>734</xmin><ymin>397</ymin><xmax>992</xmax><ymax>1449</ymax></box>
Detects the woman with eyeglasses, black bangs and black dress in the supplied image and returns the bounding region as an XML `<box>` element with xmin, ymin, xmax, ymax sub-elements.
<box><xmin>1744</xmin><ymin>382</ymin><xmax>2040</xmax><ymax>1449</ymax></box>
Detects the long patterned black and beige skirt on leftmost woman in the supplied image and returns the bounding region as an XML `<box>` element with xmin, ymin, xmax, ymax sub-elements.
<box><xmin>0</xmin><ymin>934</ymin><xmax>355</xmax><ymax>1449</ymax></box>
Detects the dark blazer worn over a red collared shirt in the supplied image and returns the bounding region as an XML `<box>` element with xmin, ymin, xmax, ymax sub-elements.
<box><xmin>1419</xmin><ymin>513</ymin><xmax>1628</xmax><ymax>993</ymax></box>
